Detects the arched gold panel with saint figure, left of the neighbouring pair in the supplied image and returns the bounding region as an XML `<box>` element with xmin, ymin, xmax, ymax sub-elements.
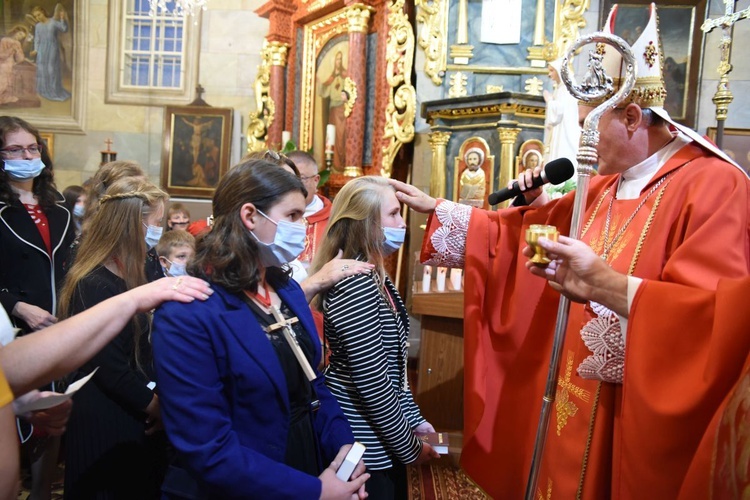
<box><xmin>453</xmin><ymin>137</ymin><xmax>495</xmax><ymax>209</ymax></box>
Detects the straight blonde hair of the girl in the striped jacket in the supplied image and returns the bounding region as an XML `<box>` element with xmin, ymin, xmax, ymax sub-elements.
<box><xmin>310</xmin><ymin>175</ymin><xmax>393</xmax><ymax>282</ymax></box>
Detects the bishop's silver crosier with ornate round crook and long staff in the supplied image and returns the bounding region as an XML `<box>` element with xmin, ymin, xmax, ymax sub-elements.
<box><xmin>525</xmin><ymin>32</ymin><xmax>638</xmax><ymax>500</ymax></box>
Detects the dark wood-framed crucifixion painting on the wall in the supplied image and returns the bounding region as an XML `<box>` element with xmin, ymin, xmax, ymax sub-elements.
<box><xmin>161</xmin><ymin>106</ymin><xmax>232</xmax><ymax>198</ymax></box>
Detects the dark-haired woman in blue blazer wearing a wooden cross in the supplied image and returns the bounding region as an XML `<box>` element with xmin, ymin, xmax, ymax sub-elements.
<box><xmin>153</xmin><ymin>158</ymin><xmax>368</xmax><ymax>499</ymax></box>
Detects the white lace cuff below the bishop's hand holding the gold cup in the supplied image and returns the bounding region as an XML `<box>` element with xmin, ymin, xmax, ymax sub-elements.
<box><xmin>578</xmin><ymin>302</ymin><xmax>625</xmax><ymax>384</ymax></box>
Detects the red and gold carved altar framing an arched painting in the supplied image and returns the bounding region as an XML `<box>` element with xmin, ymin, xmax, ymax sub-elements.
<box><xmin>253</xmin><ymin>0</ymin><xmax>416</xmax><ymax>195</ymax></box>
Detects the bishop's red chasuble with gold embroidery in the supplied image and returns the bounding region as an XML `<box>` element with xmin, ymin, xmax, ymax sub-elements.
<box><xmin>422</xmin><ymin>144</ymin><xmax>750</xmax><ymax>499</ymax></box>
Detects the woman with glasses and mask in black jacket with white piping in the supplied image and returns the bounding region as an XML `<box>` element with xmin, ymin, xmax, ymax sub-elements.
<box><xmin>0</xmin><ymin>116</ymin><xmax>75</xmax><ymax>498</ymax></box>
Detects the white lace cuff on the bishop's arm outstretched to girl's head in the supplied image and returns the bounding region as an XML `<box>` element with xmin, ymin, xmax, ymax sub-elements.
<box><xmin>425</xmin><ymin>200</ymin><xmax>471</xmax><ymax>268</ymax></box>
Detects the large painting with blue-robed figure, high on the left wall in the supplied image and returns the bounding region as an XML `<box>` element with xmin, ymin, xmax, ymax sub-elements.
<box><xmin>0</xmin><ymin>0</ymin><xmax>90</xmax><ymax>132</ymax></box>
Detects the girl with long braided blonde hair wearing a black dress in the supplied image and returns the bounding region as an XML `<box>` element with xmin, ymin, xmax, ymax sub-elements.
<box><xmin>60</xmin><ymin>177</ymin><xmax>168</xmax><ymax>499</ymax></box>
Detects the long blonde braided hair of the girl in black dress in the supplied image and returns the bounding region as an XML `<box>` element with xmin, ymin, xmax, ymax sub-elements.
<box><xmin>59</xmin><ymin>177</ymin><xmax>169</xmax><ymax>318</ymax></box>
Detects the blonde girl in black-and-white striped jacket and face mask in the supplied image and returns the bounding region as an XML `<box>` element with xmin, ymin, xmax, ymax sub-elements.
<box><xmin>312</xmin><ymin>176</ymin><xmax>438</xmax><ymax>500</ymax></box>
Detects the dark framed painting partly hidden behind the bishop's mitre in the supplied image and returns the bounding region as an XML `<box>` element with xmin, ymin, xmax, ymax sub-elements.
<box><xmin>599</xmin><ymin>0</ymin><xmax>706</xmax><ymax>128</ymax></box>
